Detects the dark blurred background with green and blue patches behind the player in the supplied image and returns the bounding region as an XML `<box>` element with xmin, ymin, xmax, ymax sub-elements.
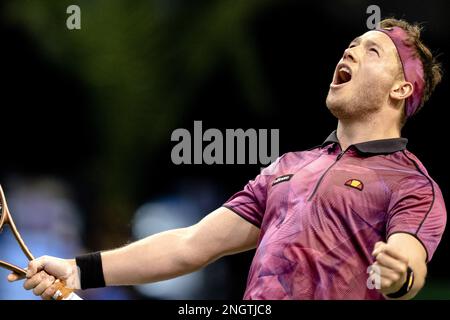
<box><xmin>0</xmin><ymin>0</ymin><xmax>450</xmax><ymax>299</ymax></box>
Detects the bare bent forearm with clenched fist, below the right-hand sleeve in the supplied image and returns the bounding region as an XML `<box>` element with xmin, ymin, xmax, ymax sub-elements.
<box><xmin>373</xmin><ymin>233</ymin><xmax>427</xmax><ymax>300</ymax></box>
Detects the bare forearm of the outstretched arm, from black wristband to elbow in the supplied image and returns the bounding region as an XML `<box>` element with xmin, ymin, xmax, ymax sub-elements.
<box><xmin>101</xmin><ymin>228</ymin><xmax>209</xmax><ymax>286</ymax></box>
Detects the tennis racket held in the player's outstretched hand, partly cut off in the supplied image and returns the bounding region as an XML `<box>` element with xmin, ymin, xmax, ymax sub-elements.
<box><xmin>0</xmin><ymin>185</ymin><xmax>82</xmax><ymax>300</ymax></box>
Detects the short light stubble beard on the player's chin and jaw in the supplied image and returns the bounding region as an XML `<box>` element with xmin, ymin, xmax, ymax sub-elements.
<box><xmin>326</xmin><ymin>79</ymin><xmax>387</xmax><ymax>120</ymax></box>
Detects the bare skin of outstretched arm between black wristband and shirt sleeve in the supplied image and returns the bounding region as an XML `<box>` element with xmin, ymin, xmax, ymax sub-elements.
<box><xmin>102</xmin><ymin>207</ymin><xmax>259</xmax><ymax>285</ymax></box>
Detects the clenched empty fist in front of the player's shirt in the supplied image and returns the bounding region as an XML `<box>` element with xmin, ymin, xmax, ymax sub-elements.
<box><xmin>369</xmin><ymin>241</ymin><xmax>409</xmax><ymax>295</ymax></box>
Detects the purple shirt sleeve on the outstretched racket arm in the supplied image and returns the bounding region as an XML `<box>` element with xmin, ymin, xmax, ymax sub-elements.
<box><xmin>223</xmin><ymin>158</ymin><xmax>280</xmax><ymax>228</ymax></box>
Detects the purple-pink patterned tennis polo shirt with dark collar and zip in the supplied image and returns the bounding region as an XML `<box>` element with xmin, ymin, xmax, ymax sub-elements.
<box><xmin>224</xmin><ymin>131</ymin><xmax>446</xmax><ymax>300</ymax></box>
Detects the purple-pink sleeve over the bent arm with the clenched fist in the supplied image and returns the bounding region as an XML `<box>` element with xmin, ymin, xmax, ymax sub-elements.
<box><xmin>386</xmin><ymin>176</ymin><xmax>447</xmax><ymax>262</ymax></box>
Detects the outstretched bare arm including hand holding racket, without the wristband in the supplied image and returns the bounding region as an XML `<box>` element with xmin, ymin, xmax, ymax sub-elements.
<box><xmin>8</xmin><ymin>207</ymin><xmax>260</xmax><ymax>299</ymax></box>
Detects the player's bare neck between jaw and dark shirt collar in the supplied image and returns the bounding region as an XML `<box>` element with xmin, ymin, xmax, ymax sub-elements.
<box><xmin>336</xmin><ymin>114</ymin><xmax>401</xmax><ymax>150</ymax></box>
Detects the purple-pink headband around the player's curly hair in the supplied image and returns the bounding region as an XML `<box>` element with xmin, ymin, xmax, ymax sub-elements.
<box><xmin>375</xmin><ymin>27</ymin><xmax>425</xmax><ymax>117</ymax></box>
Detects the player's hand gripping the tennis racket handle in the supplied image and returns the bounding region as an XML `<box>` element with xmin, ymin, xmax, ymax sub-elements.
<box><xmin>8</xmin><ymin>256</ymin><xmax>81</xmax><ymax>300</ymax></box>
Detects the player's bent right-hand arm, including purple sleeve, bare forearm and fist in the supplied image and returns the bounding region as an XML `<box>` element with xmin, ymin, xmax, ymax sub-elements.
<box><xmin>374</xmin><ymin>172</ymin><xmax>447</xmax><ymax>299</ymax></box>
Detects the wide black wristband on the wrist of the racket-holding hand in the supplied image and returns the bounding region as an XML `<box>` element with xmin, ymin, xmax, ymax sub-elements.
<box><xmin>75</xmin><ymin>252</ymin><xmax>105</xmax><ymax>290</ymax></box>
